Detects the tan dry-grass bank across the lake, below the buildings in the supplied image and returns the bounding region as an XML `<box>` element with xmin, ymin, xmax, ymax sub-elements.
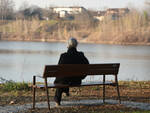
<box><xmin>0</xmin><ymin>11</ymin><xmax>150</xmax><ymax>45</ymax></box>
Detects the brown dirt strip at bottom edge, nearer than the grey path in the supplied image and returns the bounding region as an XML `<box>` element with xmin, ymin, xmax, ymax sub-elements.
<box><xmin>23</xmin><ymin>104</ymin><xmax>146</xmax><ymax>113</ymax></box>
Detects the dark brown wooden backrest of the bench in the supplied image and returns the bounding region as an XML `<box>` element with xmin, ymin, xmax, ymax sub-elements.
<box><xmin>43</xmin><ymin>63</ymin><xmax>120</xmax><ymax>77</ymax></box>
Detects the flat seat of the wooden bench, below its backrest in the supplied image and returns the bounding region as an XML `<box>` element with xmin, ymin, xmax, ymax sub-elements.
<box><xmin>36</xmin><ymin>81</ymin><xmax>115</xmax><ymax>88</ymax></box>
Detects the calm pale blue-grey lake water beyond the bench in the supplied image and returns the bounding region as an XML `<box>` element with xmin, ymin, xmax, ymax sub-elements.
<box><xmin>0</xmin><ymin>41</ymin><xmax>150</xmax><ymax>82</ymax></box>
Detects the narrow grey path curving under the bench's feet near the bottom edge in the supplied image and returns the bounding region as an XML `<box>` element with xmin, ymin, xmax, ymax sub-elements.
<box><xmin>0</xmin><ymin>100</ymin><xmax>150</xmax><ymax>113</ymax></box>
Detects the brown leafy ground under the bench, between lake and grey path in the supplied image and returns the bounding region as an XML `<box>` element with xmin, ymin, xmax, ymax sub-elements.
<box><xmin>0</xmin><ymin>82</ymin><xmax>150</xmax><ymax>106</ymax></box>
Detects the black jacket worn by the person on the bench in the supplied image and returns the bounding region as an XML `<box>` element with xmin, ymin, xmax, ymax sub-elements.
<box><xmin>54</xmin><ymin>48</ymin><xmax>89</xmax><ymax>85</ymax></box>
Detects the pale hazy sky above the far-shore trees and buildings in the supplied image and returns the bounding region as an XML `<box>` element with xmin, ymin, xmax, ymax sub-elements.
<box><xmin>14</xmin><ymin>0</ymin><xmax>146</xmax><ymax>10</ymax></box>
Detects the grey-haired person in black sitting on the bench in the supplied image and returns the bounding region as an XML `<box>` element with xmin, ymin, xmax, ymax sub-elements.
<box><xmin>54</xmin><ymin>38</ymin><xmax>89</xmax><ymax>106</ymax></box>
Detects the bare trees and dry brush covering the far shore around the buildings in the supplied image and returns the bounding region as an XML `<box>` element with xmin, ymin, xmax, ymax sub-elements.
<box><xmin>0</xmin><ymin>0</ymin><xmax>150</xmax><ymax>45</ymax></box>
